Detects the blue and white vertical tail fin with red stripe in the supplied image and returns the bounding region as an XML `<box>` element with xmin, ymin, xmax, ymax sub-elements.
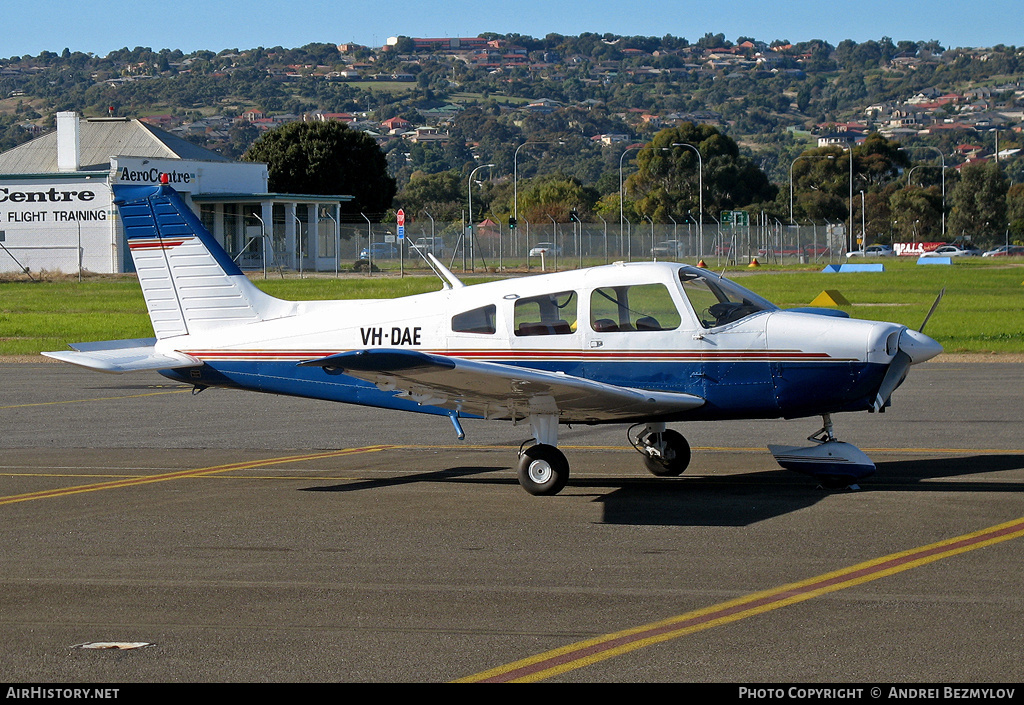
<box><xmin>114</xmin><ymin>185</ymin><xmax>291</xmax><ymax>339</ymax></box>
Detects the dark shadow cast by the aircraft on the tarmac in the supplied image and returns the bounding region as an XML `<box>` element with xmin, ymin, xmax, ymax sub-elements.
<box><xmin>305</xmin><ymin>454</ymin><xmax>1024</xmax><ymax>527</ymax></box>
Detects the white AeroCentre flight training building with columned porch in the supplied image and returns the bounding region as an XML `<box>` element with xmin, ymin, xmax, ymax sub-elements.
<box><xmin>0</xmin><ymin>113</ymin><xmax>351</xmax><ymax>274</ymax></box>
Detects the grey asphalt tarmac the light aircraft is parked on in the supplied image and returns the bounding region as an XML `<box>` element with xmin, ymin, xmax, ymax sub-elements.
<box><xmin>0</xmin><ymin>358</ymin><xmax>1024</xmax><ymax>687</ymax></box>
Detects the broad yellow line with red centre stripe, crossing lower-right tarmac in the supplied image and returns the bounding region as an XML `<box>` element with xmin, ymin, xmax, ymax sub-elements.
<box><xmin>456</xmin><ymin>517</ymin><xmax>1024</xmax><ymax>682</ymax></box>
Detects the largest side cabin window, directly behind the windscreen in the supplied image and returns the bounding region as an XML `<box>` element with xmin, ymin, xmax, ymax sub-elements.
<box><xmin>590</xmin><ymin>284</ymin><xmax>681</xmax><ymax>333</ymax></box>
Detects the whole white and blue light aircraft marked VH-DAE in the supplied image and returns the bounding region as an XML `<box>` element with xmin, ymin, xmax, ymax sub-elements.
<box><xmin>43</xmin><ymin>185</ymin><xmax>942</xmax><ymax>495</ymax></box>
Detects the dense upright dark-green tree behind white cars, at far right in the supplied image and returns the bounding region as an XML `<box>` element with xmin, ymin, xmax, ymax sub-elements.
<box><xmin>948</xmin><ymin>162</ymin><xmax>1009</xmax><ymax>247</ymax></box>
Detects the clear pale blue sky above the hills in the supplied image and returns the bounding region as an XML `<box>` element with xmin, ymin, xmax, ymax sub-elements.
<box><xmin>8</xmin><ymin>0</ymin><xmax>1024</xmax><ymax>57</ymax></box>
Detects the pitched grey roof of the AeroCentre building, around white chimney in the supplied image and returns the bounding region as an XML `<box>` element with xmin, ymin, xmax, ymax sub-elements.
<box><xmin>0</xmin><ymin>118</ymin><xmax>231</xmax><ymax>174</ymax></box>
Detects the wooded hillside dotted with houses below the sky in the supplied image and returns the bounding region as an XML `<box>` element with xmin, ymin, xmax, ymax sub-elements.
<box><xmin>0</xmin><ymin>33</ymin><xmax>1024</xmax><ymax>241</ymax></box>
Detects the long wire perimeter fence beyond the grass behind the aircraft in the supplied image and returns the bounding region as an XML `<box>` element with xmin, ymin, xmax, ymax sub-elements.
<box><xmin>239</xmin><ymin>221</ymin><xmax>848</xmax><ymax>274</ymax></box>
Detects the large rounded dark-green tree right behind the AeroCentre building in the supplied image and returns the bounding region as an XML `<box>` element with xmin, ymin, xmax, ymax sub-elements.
<box><xmin>243</xmin><ymin>122</ymin><xmax>395</xmax><ymax>214</ymax></box>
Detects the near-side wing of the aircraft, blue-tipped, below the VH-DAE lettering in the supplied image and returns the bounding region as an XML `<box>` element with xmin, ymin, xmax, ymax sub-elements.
<box><xmin>299</xmin><ymin>349</ymin><xmax>705</xmax><ymax>423</ymax></box>
